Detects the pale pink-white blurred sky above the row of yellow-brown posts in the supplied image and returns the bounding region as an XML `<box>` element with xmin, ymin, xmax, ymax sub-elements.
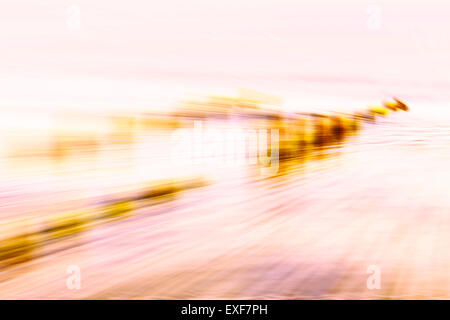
<box><xmin>0</xmin><ymin>0</ymin><xmax>450</xmax><ymax>112</ymax></box>
